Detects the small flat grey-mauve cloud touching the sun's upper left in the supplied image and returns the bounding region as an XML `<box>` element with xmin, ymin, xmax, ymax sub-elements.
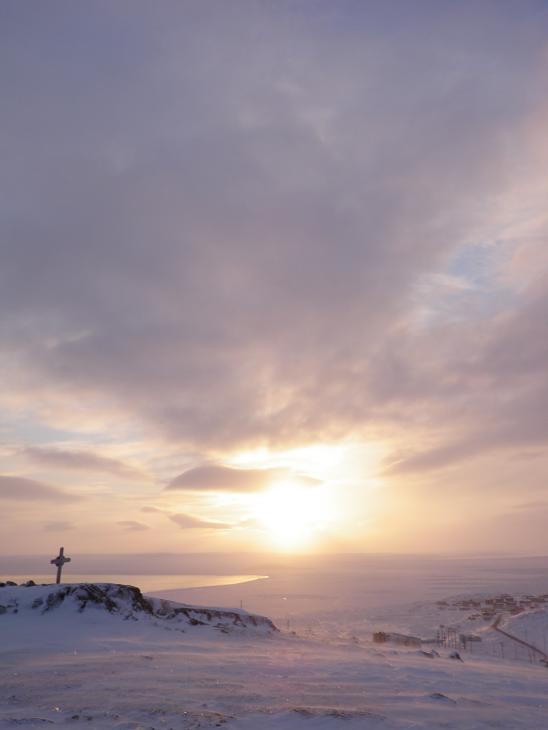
<box><xmin>166</xmin><ymin>465</ymin><xmax>319</xmax><ymax>492</ymax></box>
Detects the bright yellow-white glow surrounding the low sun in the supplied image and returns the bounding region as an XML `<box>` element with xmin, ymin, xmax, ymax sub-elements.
<box><xmin>225</xmin><ymin>441</ymin><xmax>388</xmax><ymax>552</ymax></box>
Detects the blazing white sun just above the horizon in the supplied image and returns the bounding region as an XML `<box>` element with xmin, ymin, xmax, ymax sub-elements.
<box><xmin>255</xmin><ymin>482</ymin><xmax>330</xmax><ymax>550</ymax></box>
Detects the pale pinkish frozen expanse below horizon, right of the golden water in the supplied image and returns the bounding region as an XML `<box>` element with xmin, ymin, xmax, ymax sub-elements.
<box><xmin>147</xmin><ymin>554</ymin><xmax>548</xmax><ymax>628</ymax></box>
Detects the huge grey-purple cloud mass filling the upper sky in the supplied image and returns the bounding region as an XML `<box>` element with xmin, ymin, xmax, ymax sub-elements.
<box><xmin>0</xmin><ymin>3</ymin><xmax>546</xmax><ymax>456</ymax></box>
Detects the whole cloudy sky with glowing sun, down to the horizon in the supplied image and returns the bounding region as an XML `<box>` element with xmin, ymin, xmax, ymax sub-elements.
<box><xmin>0</xmin><ymin>0</ymin><xmax>548</xmax><ymax>554</ymax></box>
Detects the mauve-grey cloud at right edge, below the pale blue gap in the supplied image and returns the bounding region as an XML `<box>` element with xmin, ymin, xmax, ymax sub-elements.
<box><xmin>379</xmin><ymin>284</ymin><xmax>548</xmax><ymax>474</ymax></box>
